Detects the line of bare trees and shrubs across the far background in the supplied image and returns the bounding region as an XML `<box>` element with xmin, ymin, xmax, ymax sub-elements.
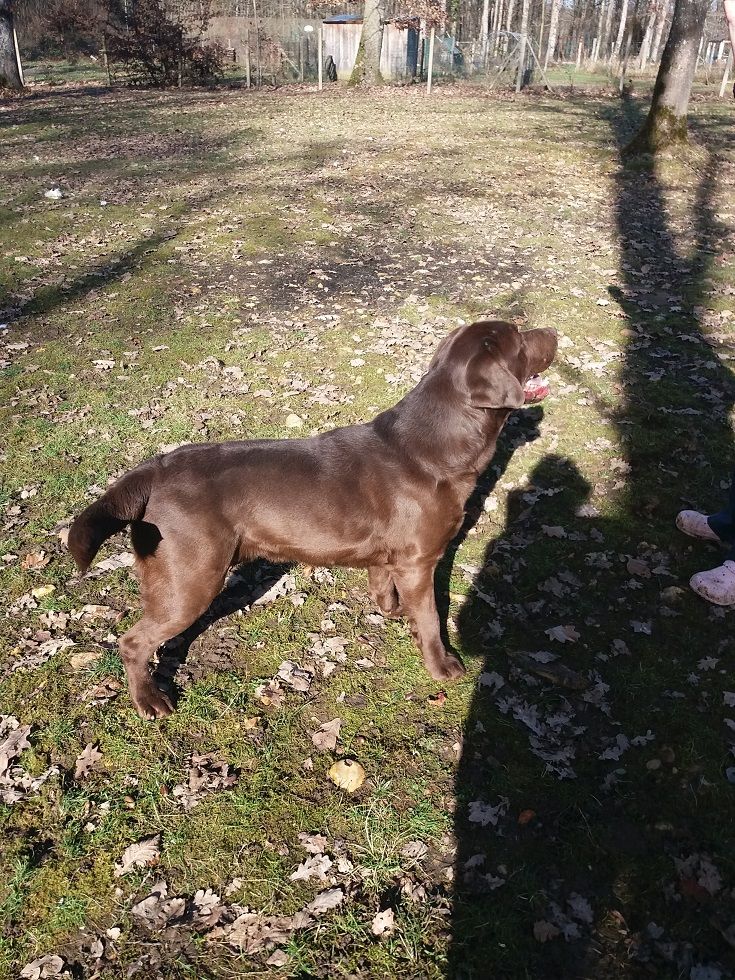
<box><xmin>5</xmin><ymin>0</ymin><xmax>727</xmax><ymax>68</ymax></box>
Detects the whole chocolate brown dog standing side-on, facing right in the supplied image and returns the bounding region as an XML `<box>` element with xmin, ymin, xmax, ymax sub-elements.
<box><xmin>69</xmin><ymin>321</ymin><xmax>556</xmax><ymax>719</ymax></box>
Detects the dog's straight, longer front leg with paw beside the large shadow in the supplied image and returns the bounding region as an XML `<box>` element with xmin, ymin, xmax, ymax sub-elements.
<box><xmin>393</xmin><ymin>564</ymin><xmax>465</xmax><ymax>681</ymax></box>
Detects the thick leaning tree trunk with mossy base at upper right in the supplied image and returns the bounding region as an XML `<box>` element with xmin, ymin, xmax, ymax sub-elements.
<box><xmin>624</xmin><ymin>0</ymin><xmax>709</xmax><ymax>156</ymax></box>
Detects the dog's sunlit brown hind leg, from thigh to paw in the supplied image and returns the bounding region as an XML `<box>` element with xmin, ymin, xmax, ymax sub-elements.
<box><xmin>120</xmin><ymin>542</ymin><xmax>229</xmax><ymax>721</ymax></box>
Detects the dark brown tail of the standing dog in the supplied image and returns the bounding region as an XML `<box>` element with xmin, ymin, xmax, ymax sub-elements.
<box><xmin>67</xmin><ymin>460</ymin><xmax>155</xmax><ymax>574</ymax></box>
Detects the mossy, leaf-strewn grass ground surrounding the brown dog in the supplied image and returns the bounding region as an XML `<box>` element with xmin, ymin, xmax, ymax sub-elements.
<box><xmin>0</xmin><ymin>72</ymin><xmax>735</xmax><ymax>980</ymax></box>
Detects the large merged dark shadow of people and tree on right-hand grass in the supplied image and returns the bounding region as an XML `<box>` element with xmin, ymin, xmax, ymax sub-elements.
<box><xmin>448</xmin><ymin>95</ymin><xmax>735</xmax><ymax>980</ymax></box>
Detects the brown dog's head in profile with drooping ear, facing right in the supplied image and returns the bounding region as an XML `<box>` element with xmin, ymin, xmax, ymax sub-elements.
<box><xmin>431</xmin><ymin>320</ymin><xmax>557</xmax><ymax>409</ymax></box>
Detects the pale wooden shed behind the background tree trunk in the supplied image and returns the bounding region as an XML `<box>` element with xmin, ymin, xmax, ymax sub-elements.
<box><xmin>322</xmin><ymin>14</ymin><xmax>419</xmax><ymax>81</ymax></box>
